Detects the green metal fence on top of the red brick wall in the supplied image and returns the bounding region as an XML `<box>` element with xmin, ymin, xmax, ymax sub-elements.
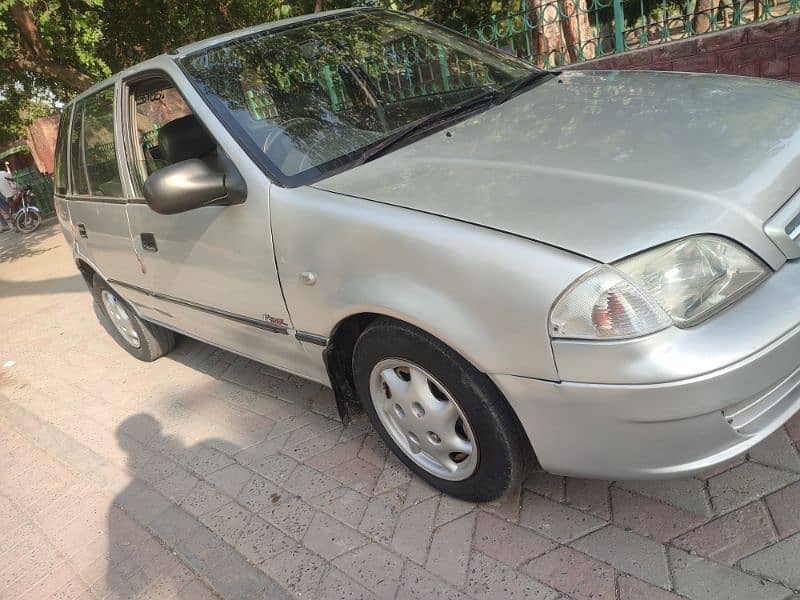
<box><xmin>465</xmin><ymin>0</ymin><xmax>800</xmax><ymax>68</ymax></box>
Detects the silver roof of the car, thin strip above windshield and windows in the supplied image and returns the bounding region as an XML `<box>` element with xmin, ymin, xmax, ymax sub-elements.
<box><xmin>64</xmin><ymin>7</ymin><xmax>383</xmax><ymax>109</ymax></box>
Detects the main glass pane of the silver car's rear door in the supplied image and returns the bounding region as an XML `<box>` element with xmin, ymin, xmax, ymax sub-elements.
<box><xmin>83</xmin><ymin>86</ymin><xmax>123</xmax><ymax>198</ymax></box>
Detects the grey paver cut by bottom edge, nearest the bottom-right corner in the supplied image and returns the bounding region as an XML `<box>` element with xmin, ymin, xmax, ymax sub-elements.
<box><xmin>669</xmin><ymin>548</ymin><xmax>792</xmax><ymax>600</ymax></box>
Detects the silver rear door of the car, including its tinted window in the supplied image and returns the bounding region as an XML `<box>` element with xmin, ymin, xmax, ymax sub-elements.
<box><xmin>68</xmin><ymin>84</ymin><xmax>144</xmax><ymax>292</ymax></box>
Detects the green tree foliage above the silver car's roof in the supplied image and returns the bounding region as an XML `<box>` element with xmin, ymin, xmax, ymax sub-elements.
<box><xmin>0</xmin><ymin>0</ymin><xmax>520</xmax><ymax>144</ymax></box>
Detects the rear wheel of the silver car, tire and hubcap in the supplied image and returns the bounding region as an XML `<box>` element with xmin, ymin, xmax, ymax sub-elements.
<box><xmin>92</xmin><ymin>274</ymin><xmax>175</xmax><ymax>362</ymax></box>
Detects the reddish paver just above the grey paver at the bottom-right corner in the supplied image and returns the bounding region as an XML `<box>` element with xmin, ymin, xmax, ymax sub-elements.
<box><xmin>673</xmin><ymin>502</ymin><xmax>776</xmax><ymax>565</ymax></box>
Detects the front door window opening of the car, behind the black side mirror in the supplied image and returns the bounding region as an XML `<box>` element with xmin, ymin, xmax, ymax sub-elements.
<box><xmin>128</xmin><ymin>78</ymin><xmax>193</xmax><ymax>195</ymax></box>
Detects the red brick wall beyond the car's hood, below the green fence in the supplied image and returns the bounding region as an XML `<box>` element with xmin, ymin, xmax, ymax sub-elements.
<box><xmin>572</xmin><ymin>15</ymin><xmax>800</xmax><ymax>82</ymax></box>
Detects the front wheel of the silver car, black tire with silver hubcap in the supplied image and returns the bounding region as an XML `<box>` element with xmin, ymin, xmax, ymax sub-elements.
<box><xmin>353</xmin><ymin>318</ymin><xmax>532</xmax><ymax>502</ymax></box>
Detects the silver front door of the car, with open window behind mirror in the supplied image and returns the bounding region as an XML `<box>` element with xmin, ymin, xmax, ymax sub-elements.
<box><xmin>123</xmin><ymin>72</ymin><xmax>312</xmax><ymax>376</ymax></box>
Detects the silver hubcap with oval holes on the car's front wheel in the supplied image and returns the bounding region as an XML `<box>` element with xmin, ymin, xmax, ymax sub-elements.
<box><xmin>370</xmin><ymin>358</ymin><xmax>478</xmax><ymax>481</ymax></box>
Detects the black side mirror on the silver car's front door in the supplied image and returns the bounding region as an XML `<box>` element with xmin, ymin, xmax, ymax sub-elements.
<box><xmin>144</xmin><ymin>158</ymin><xmax>246</xmax><ymax>215</ymax></box>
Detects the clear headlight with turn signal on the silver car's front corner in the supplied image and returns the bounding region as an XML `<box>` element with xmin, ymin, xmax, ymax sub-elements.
<box><xmin>550</xmin><ymin>235</ymin><xmax>769</xmax><ymax>339</ymax></box>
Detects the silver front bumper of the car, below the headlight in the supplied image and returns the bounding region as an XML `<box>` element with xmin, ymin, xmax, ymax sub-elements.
<box><xmin>492</xmin><ymin>262</ymin><xmax>800</xmax><ymax>479</ymax></box>
